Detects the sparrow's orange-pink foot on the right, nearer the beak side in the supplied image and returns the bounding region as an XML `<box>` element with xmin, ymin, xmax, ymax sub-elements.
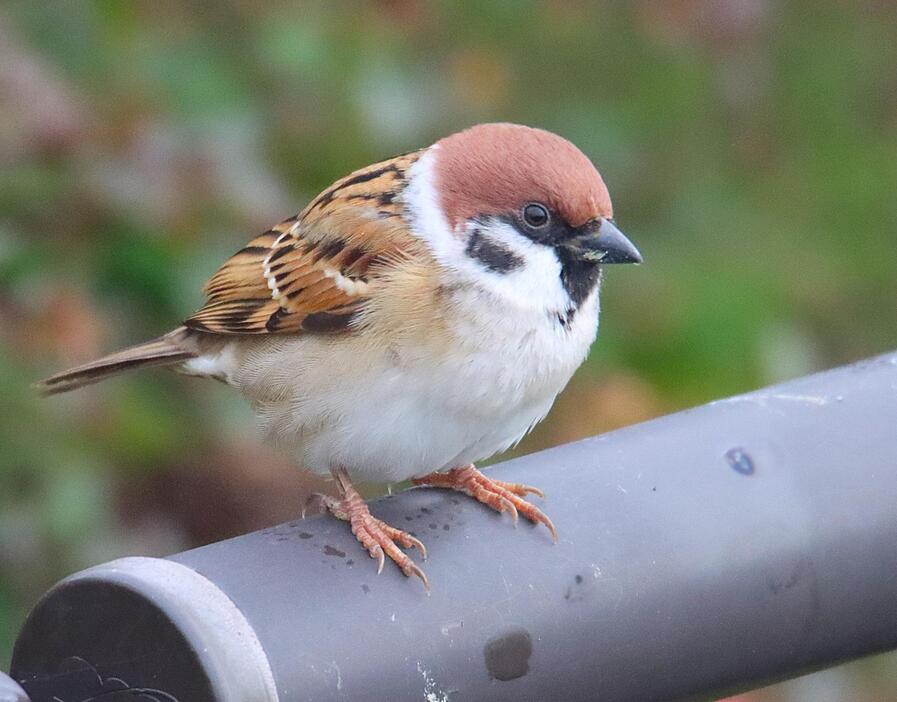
<box><xmin>411</xmin><ymin>463</ymin><xmax>558</xmax><ymax>543</ymax></box>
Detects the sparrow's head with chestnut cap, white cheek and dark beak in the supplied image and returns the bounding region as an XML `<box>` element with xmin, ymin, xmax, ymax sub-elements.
<box><xmin>408</xmin><ymin>123</ymin><xmax>642</xmax><ymax>314</ymax></box>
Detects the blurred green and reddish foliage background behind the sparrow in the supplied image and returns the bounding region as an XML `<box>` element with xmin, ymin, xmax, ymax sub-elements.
<box><xmin>0</xmin><ymin>0</ymin><xmax>897</xmax><ymax>702</ymax></box>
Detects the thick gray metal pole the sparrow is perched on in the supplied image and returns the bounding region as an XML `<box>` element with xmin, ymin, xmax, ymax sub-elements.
<box><xmin>12</xmin><ymin>354</ymin><xmax>897</xmax><ymax>702</ymax></box>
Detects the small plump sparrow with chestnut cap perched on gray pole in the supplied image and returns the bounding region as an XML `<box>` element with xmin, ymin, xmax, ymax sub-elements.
<box><xmin>36</xmin><ymin>123</ymin><xmax>642</xmax><ymax>592</ymax></box>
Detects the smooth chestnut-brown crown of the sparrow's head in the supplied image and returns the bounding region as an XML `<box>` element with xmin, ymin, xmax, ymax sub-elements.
<box><xmin>436</xmin><ymin>123</ymin><xmax>613</xmax><ymax>229</ymax></box>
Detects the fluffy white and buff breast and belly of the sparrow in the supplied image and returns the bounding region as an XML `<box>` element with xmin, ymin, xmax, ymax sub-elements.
<box><xmin>219</xmin><ymin>292</ymin><xmax>598</xmax><ymax>482</ymax></box>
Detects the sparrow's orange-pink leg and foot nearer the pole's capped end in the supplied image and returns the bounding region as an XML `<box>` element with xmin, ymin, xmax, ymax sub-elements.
<box><xmin>302</xmin><ymin>468</ymin><xmax>430</xmax><ymax>592</ymax></box>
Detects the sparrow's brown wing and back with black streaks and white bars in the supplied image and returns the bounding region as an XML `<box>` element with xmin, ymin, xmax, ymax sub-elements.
<box><xmin>184</xmin><ymin>153</ymin><xmax>418</xmax><ymax>334</ymax></box>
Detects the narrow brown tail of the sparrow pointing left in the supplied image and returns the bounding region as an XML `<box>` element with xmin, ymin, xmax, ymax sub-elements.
<box><xmin>34</xmin><ymin>329</ymin><xmax>197</xmax><ymax>395</ymax></box>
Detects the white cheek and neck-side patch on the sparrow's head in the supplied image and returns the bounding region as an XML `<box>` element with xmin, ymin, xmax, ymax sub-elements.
<box><xmin>405</xmin><ymin>147</ymin><xmax>570</xmax><ymax>312</ymax></box>
